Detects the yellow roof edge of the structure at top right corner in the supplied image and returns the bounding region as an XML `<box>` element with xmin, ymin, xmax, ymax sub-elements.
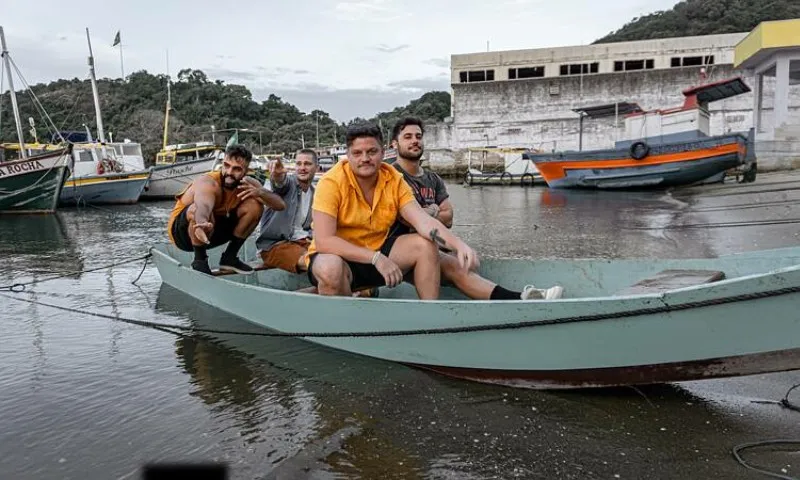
<box><xmin>733</xmin><ymin>18</ymin><xmax>800</xmax><ymax>68</ymax></box>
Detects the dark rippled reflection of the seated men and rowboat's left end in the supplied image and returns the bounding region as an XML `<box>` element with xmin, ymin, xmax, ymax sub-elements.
<box><xmin>156</xmin><ymin>285</ymin><xmax>438</xmax><ymax>478</ymax></box>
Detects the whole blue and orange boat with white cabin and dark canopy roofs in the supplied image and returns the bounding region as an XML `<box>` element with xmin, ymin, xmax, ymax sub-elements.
<box><xmin>523</xmin><ymin>77</ymin><xmax>756</xmax><ymax>189</ymax></box>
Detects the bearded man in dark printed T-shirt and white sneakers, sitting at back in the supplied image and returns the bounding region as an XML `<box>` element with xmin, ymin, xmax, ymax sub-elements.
<box><xmin>390</xmin><ymin>117</ymin><xmax>564</xmax><ymax>300</ymax></box>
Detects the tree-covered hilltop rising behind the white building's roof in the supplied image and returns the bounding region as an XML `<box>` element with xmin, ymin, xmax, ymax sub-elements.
<box><xmin>594</xmin><ymin>0</ymin><xmax>800</xmax><ymax>44</ymax></box>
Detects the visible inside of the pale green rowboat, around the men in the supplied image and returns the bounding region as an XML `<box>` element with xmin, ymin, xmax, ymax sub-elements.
<box><xmin>153</xmin><ymin>239</ymin><xmax>800</xmax><ymax>300</ymax></box>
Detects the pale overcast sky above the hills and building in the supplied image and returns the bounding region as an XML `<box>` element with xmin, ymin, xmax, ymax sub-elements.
<box><xmin>0</xmin><ymin>0</ymin><xmax>677</xmax><ymax>121</ymax></box>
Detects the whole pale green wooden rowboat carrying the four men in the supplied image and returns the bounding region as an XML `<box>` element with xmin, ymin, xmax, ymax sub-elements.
<box><xmin>151</xmin><ymin>241</ymin><xmax>800</xmax><ymax>388</ymax></box>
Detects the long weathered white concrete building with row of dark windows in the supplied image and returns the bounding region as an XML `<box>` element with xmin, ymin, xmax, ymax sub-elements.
<box><xmin>426</xmin><ymin>28</ymin><xmax>800</xmax><ymax>171</ymax></box>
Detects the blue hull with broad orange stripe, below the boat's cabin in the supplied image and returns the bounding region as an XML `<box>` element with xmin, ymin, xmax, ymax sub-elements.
<box><xmin>528</xmin><ymin>134</ymin><xmax>747</xmax><ymax>189</ymax></box>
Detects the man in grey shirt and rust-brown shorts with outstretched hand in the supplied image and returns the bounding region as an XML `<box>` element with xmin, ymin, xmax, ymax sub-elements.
<box><xmin>256</xmin><ymin>149</ymin><xmax>319</xmax><ymax>273</ymax></box>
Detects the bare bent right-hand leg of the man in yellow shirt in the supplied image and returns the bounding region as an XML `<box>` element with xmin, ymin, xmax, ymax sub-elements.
<box><xmin>389</xmin><ymin>233</ymin><xmax>441</xmax><ymax>300</ymax></box>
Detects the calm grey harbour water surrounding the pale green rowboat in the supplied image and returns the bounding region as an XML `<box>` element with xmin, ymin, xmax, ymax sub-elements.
<box><xmin>0</xmin><ymin>181</ymin><xmax>800</xmax><ymax>479</ymax></box>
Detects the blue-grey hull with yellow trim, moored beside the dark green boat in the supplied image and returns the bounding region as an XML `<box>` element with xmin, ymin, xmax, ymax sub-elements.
<box><xmin>59</xmin><ymin>170</ymin><xmax>150</xmax><ymax>206</ymax></box>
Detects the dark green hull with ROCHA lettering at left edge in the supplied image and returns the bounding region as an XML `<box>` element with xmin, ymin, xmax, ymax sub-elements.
<box><xmin>0</xmin><ymin>150</ymin><xmax>71</xmax><ymax>214</ymax></box>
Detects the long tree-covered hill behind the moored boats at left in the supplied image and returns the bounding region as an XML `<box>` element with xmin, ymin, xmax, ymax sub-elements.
<box><xmin>0</xmin><ymin>69</ymin><xmax>450</xmax><ymax>161</ymax></box>
